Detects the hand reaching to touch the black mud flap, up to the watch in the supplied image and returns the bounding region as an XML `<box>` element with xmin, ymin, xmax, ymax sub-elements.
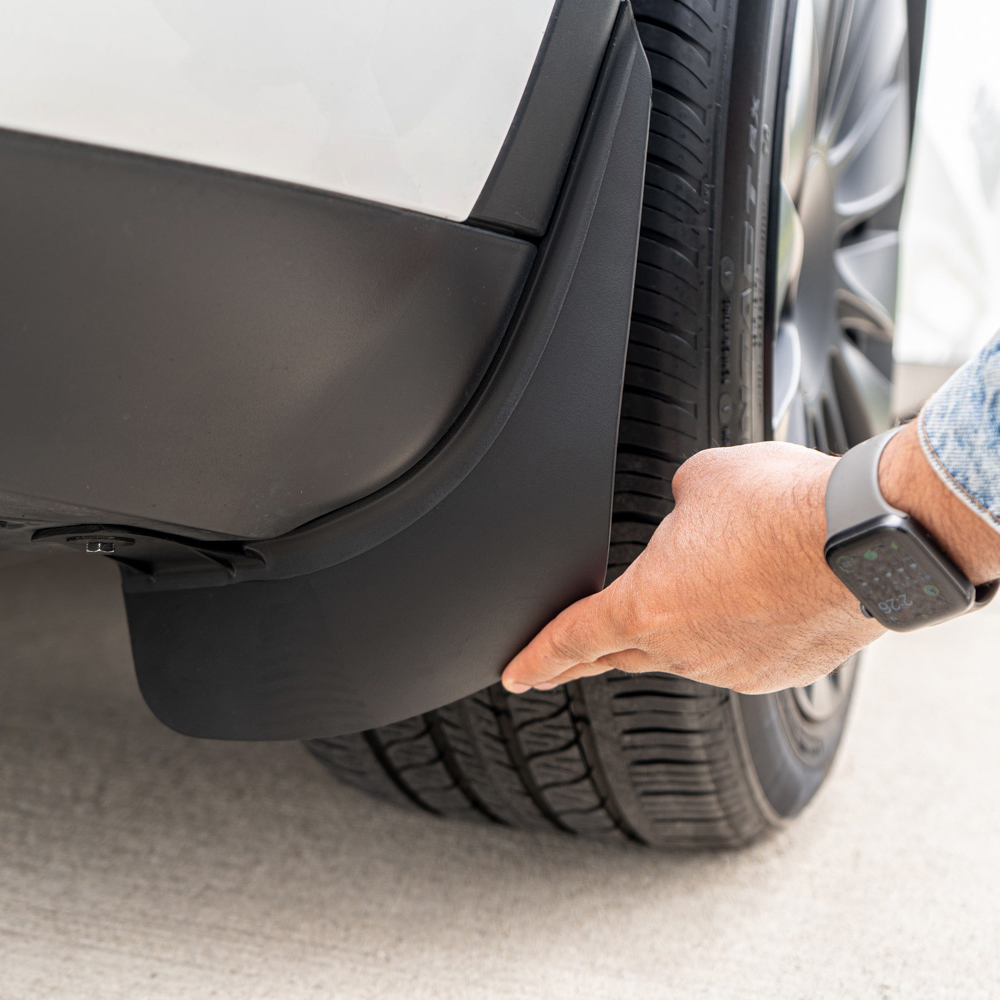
<box><xmin>503</xmin><ymin>442</ymin><xmax>884</xmax><ymax>694</ymax></box>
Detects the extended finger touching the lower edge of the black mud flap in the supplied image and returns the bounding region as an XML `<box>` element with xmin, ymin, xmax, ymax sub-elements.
<box><xmin>502</xmin><ymin>578</ymin><xmax>635</xmax><ymax>694</ymax></box>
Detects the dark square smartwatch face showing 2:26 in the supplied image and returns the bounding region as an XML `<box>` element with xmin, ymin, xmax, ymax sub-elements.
<box><xmin>826</xmin><ymin>516</ymin><xmax>975</xmax><ymax>631</ymax></box>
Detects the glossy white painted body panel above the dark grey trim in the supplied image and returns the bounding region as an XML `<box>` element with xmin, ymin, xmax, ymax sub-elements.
<box><xmin>0</xmin><ymin>0</ymin><xmax>554</xmax><ymax>219</ymax></box>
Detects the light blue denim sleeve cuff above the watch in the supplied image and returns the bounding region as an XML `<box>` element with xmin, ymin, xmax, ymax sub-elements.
<box><xmin>918</xmin><ymin>333</ymin><xmax>1000</xmax><ymax>531</ymax></box>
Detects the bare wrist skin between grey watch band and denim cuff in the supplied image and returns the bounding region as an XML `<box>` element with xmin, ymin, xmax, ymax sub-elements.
<box><xmin>878</xmin><ymin>421</ymin><xmax>1000</xmax><ymax>584</ymax></box>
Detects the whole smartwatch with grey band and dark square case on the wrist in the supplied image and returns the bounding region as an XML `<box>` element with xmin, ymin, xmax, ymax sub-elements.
<box><xmin>823</xmin><ymin>427</ymin><xmax>1000</xmax><ymax>632</ymax></box>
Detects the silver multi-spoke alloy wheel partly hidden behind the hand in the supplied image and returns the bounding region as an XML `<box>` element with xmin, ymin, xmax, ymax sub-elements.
<box><xmin>769</xmin><ymin>0</ymin><xmax>910</xmax><ymax>721</ymax></box>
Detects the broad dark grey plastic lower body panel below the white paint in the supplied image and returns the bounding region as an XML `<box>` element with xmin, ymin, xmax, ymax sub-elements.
<box><xmin>0</xmin><ymin>130</ymin><xmax>535</xmax><ymax>545</ymax></box>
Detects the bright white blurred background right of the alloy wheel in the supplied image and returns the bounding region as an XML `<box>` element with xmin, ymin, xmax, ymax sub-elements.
<box><xmin>895</xmin><ymin>0</ymin><xmax>1000</xmax><ymax>365</ymax></box>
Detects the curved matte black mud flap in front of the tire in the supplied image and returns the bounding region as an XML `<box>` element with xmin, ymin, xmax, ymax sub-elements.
<box><xmin>123</xmin><ymin>6</ymin><xmax>651</xmax><ymax>739</ymax></box>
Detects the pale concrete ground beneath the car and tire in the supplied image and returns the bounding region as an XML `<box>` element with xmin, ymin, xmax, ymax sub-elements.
<box><xmin>0</xmin><ymin>556</ymin><xmax>1000</xmax><ymax>1000</ymax></box>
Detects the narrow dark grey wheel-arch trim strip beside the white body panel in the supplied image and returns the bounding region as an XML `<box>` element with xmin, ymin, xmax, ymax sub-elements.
<box><xmin>469</xmin><ymin>0</ymin><xmax>621</xmax><ymax>238</ymax></box>
